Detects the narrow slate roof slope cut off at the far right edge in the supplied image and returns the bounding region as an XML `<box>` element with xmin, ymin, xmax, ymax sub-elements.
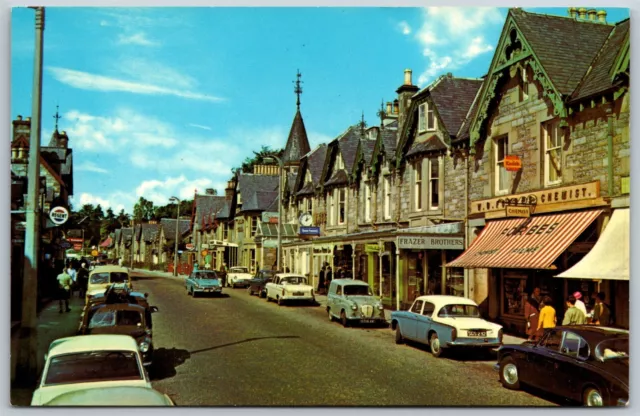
<box><xmin>571</xmin><ymin>19</ymin><xmax>630</xmax><ymax>100</ymax></box>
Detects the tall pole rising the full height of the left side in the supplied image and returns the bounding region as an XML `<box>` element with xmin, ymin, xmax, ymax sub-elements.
<box><xmin>16</xmin><ymin>7</ymin><xmax>44</xmax><ymax>385</ymax></box>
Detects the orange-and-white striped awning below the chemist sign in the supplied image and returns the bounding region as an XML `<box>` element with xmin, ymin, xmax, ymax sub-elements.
<box><xmin>446</xmin><ymin>210</ymin><xmax>602</xmax><ymax>269</ymax></box>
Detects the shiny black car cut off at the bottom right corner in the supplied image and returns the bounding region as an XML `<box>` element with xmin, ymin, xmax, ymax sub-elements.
<box><xmin>495</xmin><ymin>325</ymin><xmax>629</xmax><ymax>406</ymax></box>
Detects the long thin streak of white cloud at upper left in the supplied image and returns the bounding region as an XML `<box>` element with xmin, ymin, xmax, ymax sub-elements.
<box><xmin>47</xmin><ymin>67</ymin><xmax>223</xmax><ymax>102</ymax></box>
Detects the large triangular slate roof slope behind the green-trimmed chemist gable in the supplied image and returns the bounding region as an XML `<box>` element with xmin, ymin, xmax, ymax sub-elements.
<box><xmin>509</xmin><ymin>9</ymin><xmax>613</xmax><ymax>95</ymax></box>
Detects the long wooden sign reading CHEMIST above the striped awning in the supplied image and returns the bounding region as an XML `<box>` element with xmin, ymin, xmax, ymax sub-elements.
<box><xmin>470</xmin><ymin>181</ymin><xmax>600</xmax><ymax>215</ymax></box>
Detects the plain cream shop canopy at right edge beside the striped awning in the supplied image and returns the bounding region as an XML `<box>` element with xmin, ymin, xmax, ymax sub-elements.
<box><xmin>556</xmin><ymin>208</ymin><xmax>630</xmax><ymax>280</ymax></box>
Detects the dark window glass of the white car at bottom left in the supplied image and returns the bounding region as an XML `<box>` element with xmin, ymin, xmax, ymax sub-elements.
<box><xmin>44</xmin><ymin>351</ymin><xmax>144</xmax><ymax>386</ymax></box>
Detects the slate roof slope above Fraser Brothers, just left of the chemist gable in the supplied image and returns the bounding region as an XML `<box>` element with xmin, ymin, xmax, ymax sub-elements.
<box><xmin>430</xmin><ymin>76</ymin><xmax>482</xmax><ymax>136</ymax></box>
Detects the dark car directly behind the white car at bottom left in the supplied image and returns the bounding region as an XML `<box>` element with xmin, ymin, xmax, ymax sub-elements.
<box><xmin>78</xmin><ymin>303</ymin><xmax>158</xmax><ymax>366</ymax></box>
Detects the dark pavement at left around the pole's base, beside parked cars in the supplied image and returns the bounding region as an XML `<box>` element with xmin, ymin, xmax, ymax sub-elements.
<box><xmin>11</xmin><ymin>294</ymin><xmax>84</xmax><ymax>406</ymax></box>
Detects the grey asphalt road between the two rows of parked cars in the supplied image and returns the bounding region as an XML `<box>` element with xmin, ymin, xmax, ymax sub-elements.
<box><xmin>135</xmin><ymin>270</ymin><xmax>555</xmax><ymax>406</ymax></box>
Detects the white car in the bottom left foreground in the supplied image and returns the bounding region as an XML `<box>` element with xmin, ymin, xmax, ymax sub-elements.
<box><xmin>31</xmin><ymin>335</ymin><xmax>151</xmax><ymax>406</ymax></box>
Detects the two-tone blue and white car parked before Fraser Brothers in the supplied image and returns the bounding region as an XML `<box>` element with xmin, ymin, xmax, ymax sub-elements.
<box><xmin>391</xmin><ymin>295</ymin><xmax>502</xmax><ymax>357</ymax></box>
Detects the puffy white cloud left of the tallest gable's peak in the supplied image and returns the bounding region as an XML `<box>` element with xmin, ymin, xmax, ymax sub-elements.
<box><xmin>415</xmin><ymin>7</ymin><xmax>504</xmax><ymax>86</ymax></box>
